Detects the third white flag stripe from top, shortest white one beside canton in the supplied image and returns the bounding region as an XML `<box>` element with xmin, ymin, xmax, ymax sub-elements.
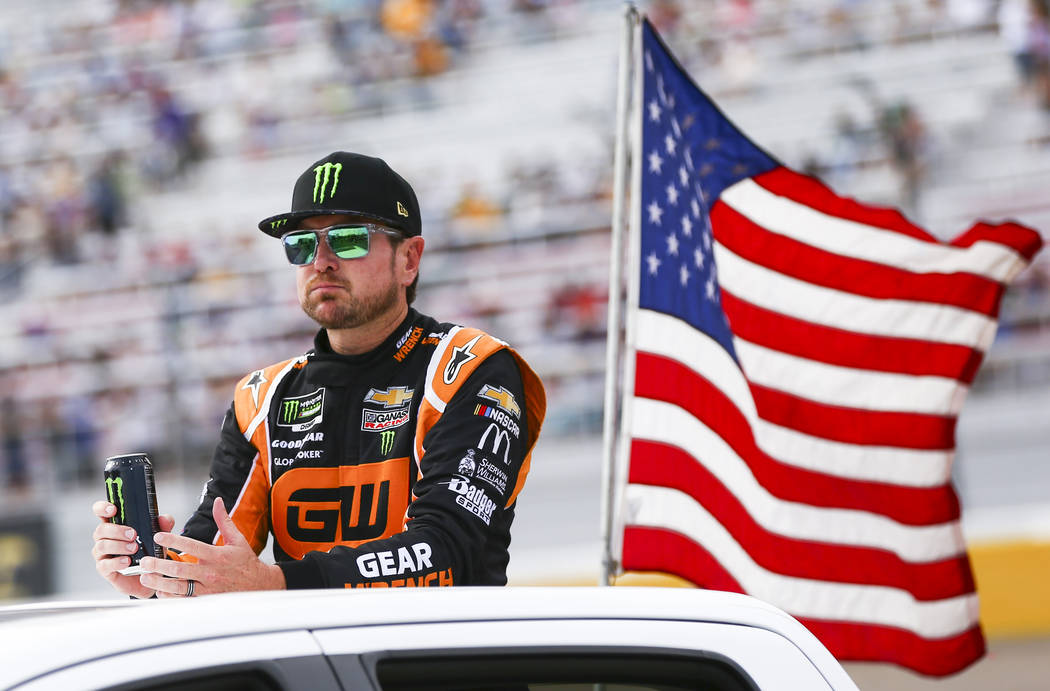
<box><xmin>733</xmin><ymin>338</ymin><xmax>969</xmax><ymax>415</ymax></box>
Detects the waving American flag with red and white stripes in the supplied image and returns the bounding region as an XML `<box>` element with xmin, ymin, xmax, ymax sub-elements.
<box><xmin>618</xmin><ymin>22</ymin><xmax>1042</xmax><ymax>675</ymax></box>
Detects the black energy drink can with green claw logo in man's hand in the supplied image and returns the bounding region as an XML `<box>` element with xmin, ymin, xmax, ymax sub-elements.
<box><xmin>103</xmin><ymin>454</ymin><xmax>164</xmax><ymax>575</ymax></box>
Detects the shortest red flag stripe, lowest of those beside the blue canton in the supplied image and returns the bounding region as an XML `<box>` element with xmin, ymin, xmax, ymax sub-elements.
<box><xmin>748</xmin><ymin>382</ymin><xmax>956</xmax><ymax>449</ymax></box>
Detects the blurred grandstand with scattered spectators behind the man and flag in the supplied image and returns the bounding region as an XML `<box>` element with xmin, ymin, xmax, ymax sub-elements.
<box><xmin>0</xmin><ymin>0</ymin><xmax>1050</xmax><ymax>634</ymax></box>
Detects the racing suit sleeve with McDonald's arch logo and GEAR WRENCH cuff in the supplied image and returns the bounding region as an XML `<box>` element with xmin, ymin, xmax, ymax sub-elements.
<box><xmin>279</xmin><ymin>350</ymin><xmax>534</xmax><ymax>588</ymax></box>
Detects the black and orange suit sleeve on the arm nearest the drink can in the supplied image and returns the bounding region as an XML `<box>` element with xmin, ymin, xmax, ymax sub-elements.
<box><xmin>182</xmin><ymin>403</ymin><xmax>269</xmax><ymax>554</ymax></box>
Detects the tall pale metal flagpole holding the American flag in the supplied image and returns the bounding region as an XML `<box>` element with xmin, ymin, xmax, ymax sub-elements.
<box><xmin>599</xmin><ymin>2</ymin><xmax>638</xmax><ymax>585</ymax></box>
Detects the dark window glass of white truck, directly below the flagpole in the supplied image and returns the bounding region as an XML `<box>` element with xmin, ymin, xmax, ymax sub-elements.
<box><xmin>375</xmin><ymin>648</ymin><xmax>756</xmax><ymax>691</ymax></box>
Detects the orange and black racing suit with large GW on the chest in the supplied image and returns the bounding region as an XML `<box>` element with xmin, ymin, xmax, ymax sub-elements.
<box><xmin>183</xmin><ymin>310</ymin><xmax>546</xmax><ymax>588</ymax></box>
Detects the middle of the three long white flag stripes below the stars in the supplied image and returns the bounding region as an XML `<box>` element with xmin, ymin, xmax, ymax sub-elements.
<box><xmin>631</xmin><ymin>398</ymin><xmax>965</xmax><ymax>563</ymax></box>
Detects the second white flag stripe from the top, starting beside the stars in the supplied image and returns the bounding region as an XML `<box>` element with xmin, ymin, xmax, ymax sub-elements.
<box><xmin>714</xmin><ymin>243</ymin><xmax>995</xmax><ymax>351</ymax></box>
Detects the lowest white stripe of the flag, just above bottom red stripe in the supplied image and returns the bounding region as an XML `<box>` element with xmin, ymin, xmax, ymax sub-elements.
<box><xmin>625</xmin><ymin>484</ymin><xmax>978</xmax><ymax>638</ymax></box>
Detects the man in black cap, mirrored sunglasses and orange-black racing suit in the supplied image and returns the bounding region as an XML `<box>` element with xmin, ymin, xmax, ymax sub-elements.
<box><xmin>92</xmin><ymin>152</ymin><xmax>546</xmax><ymax>598</ymax></box>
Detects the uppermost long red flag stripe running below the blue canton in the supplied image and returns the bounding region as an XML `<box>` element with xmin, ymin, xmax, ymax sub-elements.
<box><xmin>634</xmin><ymin>353</ymin><xmax>959</xmax><ymax>525</ymax></box>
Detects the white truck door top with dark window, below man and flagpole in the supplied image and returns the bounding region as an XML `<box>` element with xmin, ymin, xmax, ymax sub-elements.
<box><xmin>313</xmin><ymin>619</ymin><xmax>831</xmax><ymax>691</ymax></box>
